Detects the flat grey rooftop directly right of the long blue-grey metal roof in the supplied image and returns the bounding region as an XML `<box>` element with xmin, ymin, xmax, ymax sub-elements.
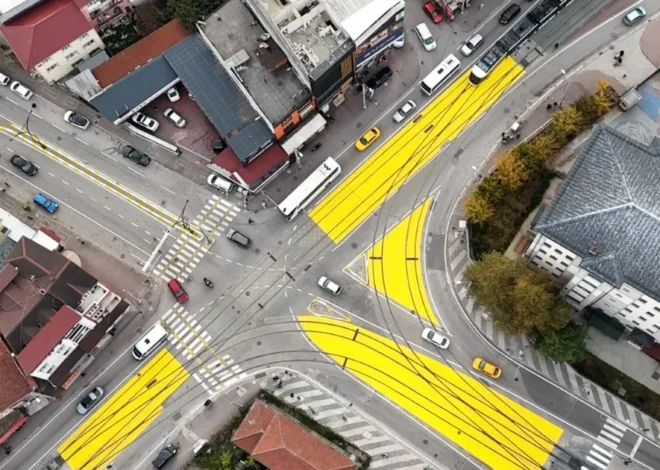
<box><xmin>204</xmin><ymin>0</ymin><xmax>310</xmax><ymax>125</ymax></box>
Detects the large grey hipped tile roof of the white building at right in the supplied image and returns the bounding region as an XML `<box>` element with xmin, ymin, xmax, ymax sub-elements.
<box><xmin>534</xmin><ymin>126</ymin><xmax>660</xmax><ymax>299</ymax></box>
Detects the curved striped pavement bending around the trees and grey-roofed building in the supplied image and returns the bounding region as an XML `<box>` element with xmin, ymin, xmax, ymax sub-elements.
<box><xmin>446</xmin><ymin>235</ymin><xmax>660</xmax><ymax>442</ymax></box>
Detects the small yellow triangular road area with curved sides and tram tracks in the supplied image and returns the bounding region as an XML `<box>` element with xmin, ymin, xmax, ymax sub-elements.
<box><xmin>366</xmin><ymin>198</ymin><xmax>439</xmax><ymax>325</ymax></box>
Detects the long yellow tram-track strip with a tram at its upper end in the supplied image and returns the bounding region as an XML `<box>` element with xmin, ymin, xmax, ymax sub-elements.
<box><xmin>309</xmin><ymin>57</ymin><xmax>523</xmax><ymax>243</ymax></box>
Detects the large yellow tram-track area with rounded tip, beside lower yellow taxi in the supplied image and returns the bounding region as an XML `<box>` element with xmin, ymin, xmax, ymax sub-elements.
<box><xmin>298</xmin><ymin>316</ymin><xmax>563</xmax><ymax>470</ymax></box>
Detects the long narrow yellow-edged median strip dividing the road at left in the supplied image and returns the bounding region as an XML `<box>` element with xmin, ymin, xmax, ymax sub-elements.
<box><xmin>0</xmin><ymin>123</ymin><xmax>201</xmax><ymax>238</ymax></box>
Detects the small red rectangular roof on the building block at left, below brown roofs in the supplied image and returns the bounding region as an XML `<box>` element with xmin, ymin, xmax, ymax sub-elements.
<box><xmin>18</xmin><ymin>305</ymin><xmax>81</xmax><ymax>374</ymax></box>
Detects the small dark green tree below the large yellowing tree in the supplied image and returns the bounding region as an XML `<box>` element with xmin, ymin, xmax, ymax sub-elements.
<box><xmin>534</xmin><ymin>322</ymin><xmax>587</xmax><ymax>364</ymax></box>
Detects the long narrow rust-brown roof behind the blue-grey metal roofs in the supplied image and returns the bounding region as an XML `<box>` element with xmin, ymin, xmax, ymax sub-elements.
<box><xmin>92</xmin><ymin>18</ymin><xmax>190</xmax><ymax>88</ymax></box>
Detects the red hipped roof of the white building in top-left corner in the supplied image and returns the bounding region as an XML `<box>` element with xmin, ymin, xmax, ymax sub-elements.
<box><xmin>0</xmin><ymin>0</ymin><xmax>94</xmax><ymax>70</ymax></box>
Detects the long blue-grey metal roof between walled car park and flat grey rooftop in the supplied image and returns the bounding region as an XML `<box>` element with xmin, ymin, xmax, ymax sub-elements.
<box><xmin>164</xmin><ymin>35</ymin><xmax>273</xmax><ymax>163</ymax></box>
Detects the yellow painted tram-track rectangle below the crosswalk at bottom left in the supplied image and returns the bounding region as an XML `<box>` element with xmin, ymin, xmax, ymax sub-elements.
<box><xmin>57</xmin><ymin>349</ymin><xmax>189</xmax><ymax>470</ymax></box>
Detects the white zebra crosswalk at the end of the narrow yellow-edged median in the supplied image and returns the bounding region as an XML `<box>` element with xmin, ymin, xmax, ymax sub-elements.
<box><xmin>153</xmin><ymin>195</ymin><xmax>240</xmax><ymax>282</ymax></box>
